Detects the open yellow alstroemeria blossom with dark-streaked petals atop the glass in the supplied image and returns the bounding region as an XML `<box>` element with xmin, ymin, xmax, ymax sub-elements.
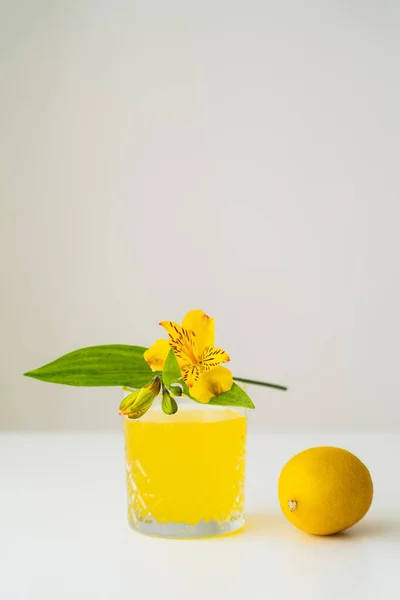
<box><xmin>144</xmin><ymin>310</ymin><xmax>232</xmax><ymax>402</ymax></box>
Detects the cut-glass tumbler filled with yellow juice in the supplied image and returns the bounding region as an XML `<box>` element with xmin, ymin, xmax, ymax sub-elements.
<box><xmin>124</xmin><ymin>404</ymin><xmax>246</xmax><ymax>538</ymax></box>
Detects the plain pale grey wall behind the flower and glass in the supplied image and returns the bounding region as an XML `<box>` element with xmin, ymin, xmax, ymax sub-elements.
<box><xmin>0</xmin><ymin>0</ymin><xmax>400</xmax><ymax>431</ymax></box>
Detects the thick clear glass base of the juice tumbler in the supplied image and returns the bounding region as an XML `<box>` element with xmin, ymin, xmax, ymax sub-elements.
<box><xmin>129</xmin><ymin>514</ymin><xmax>244</xmax><ymax>539</ymax></box>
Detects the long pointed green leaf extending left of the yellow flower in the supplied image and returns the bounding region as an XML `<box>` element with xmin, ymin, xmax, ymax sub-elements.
<box><xmin>25</xmin><ymin>344</ymin><xmax>154</xmax><ymax>388</ymax></box>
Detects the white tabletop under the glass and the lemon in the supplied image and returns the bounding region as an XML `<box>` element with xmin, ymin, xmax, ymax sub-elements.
<box><xmin>0</xmin><ymin>433</ymin><xmax>400</xmax><ymax>600</ymax></box>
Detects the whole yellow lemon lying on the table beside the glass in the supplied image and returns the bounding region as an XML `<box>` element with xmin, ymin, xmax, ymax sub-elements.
<box><xmin>278</xmin><ymin>446</ymin><xmax>373</xmax><ymax>535</ymax></box>
